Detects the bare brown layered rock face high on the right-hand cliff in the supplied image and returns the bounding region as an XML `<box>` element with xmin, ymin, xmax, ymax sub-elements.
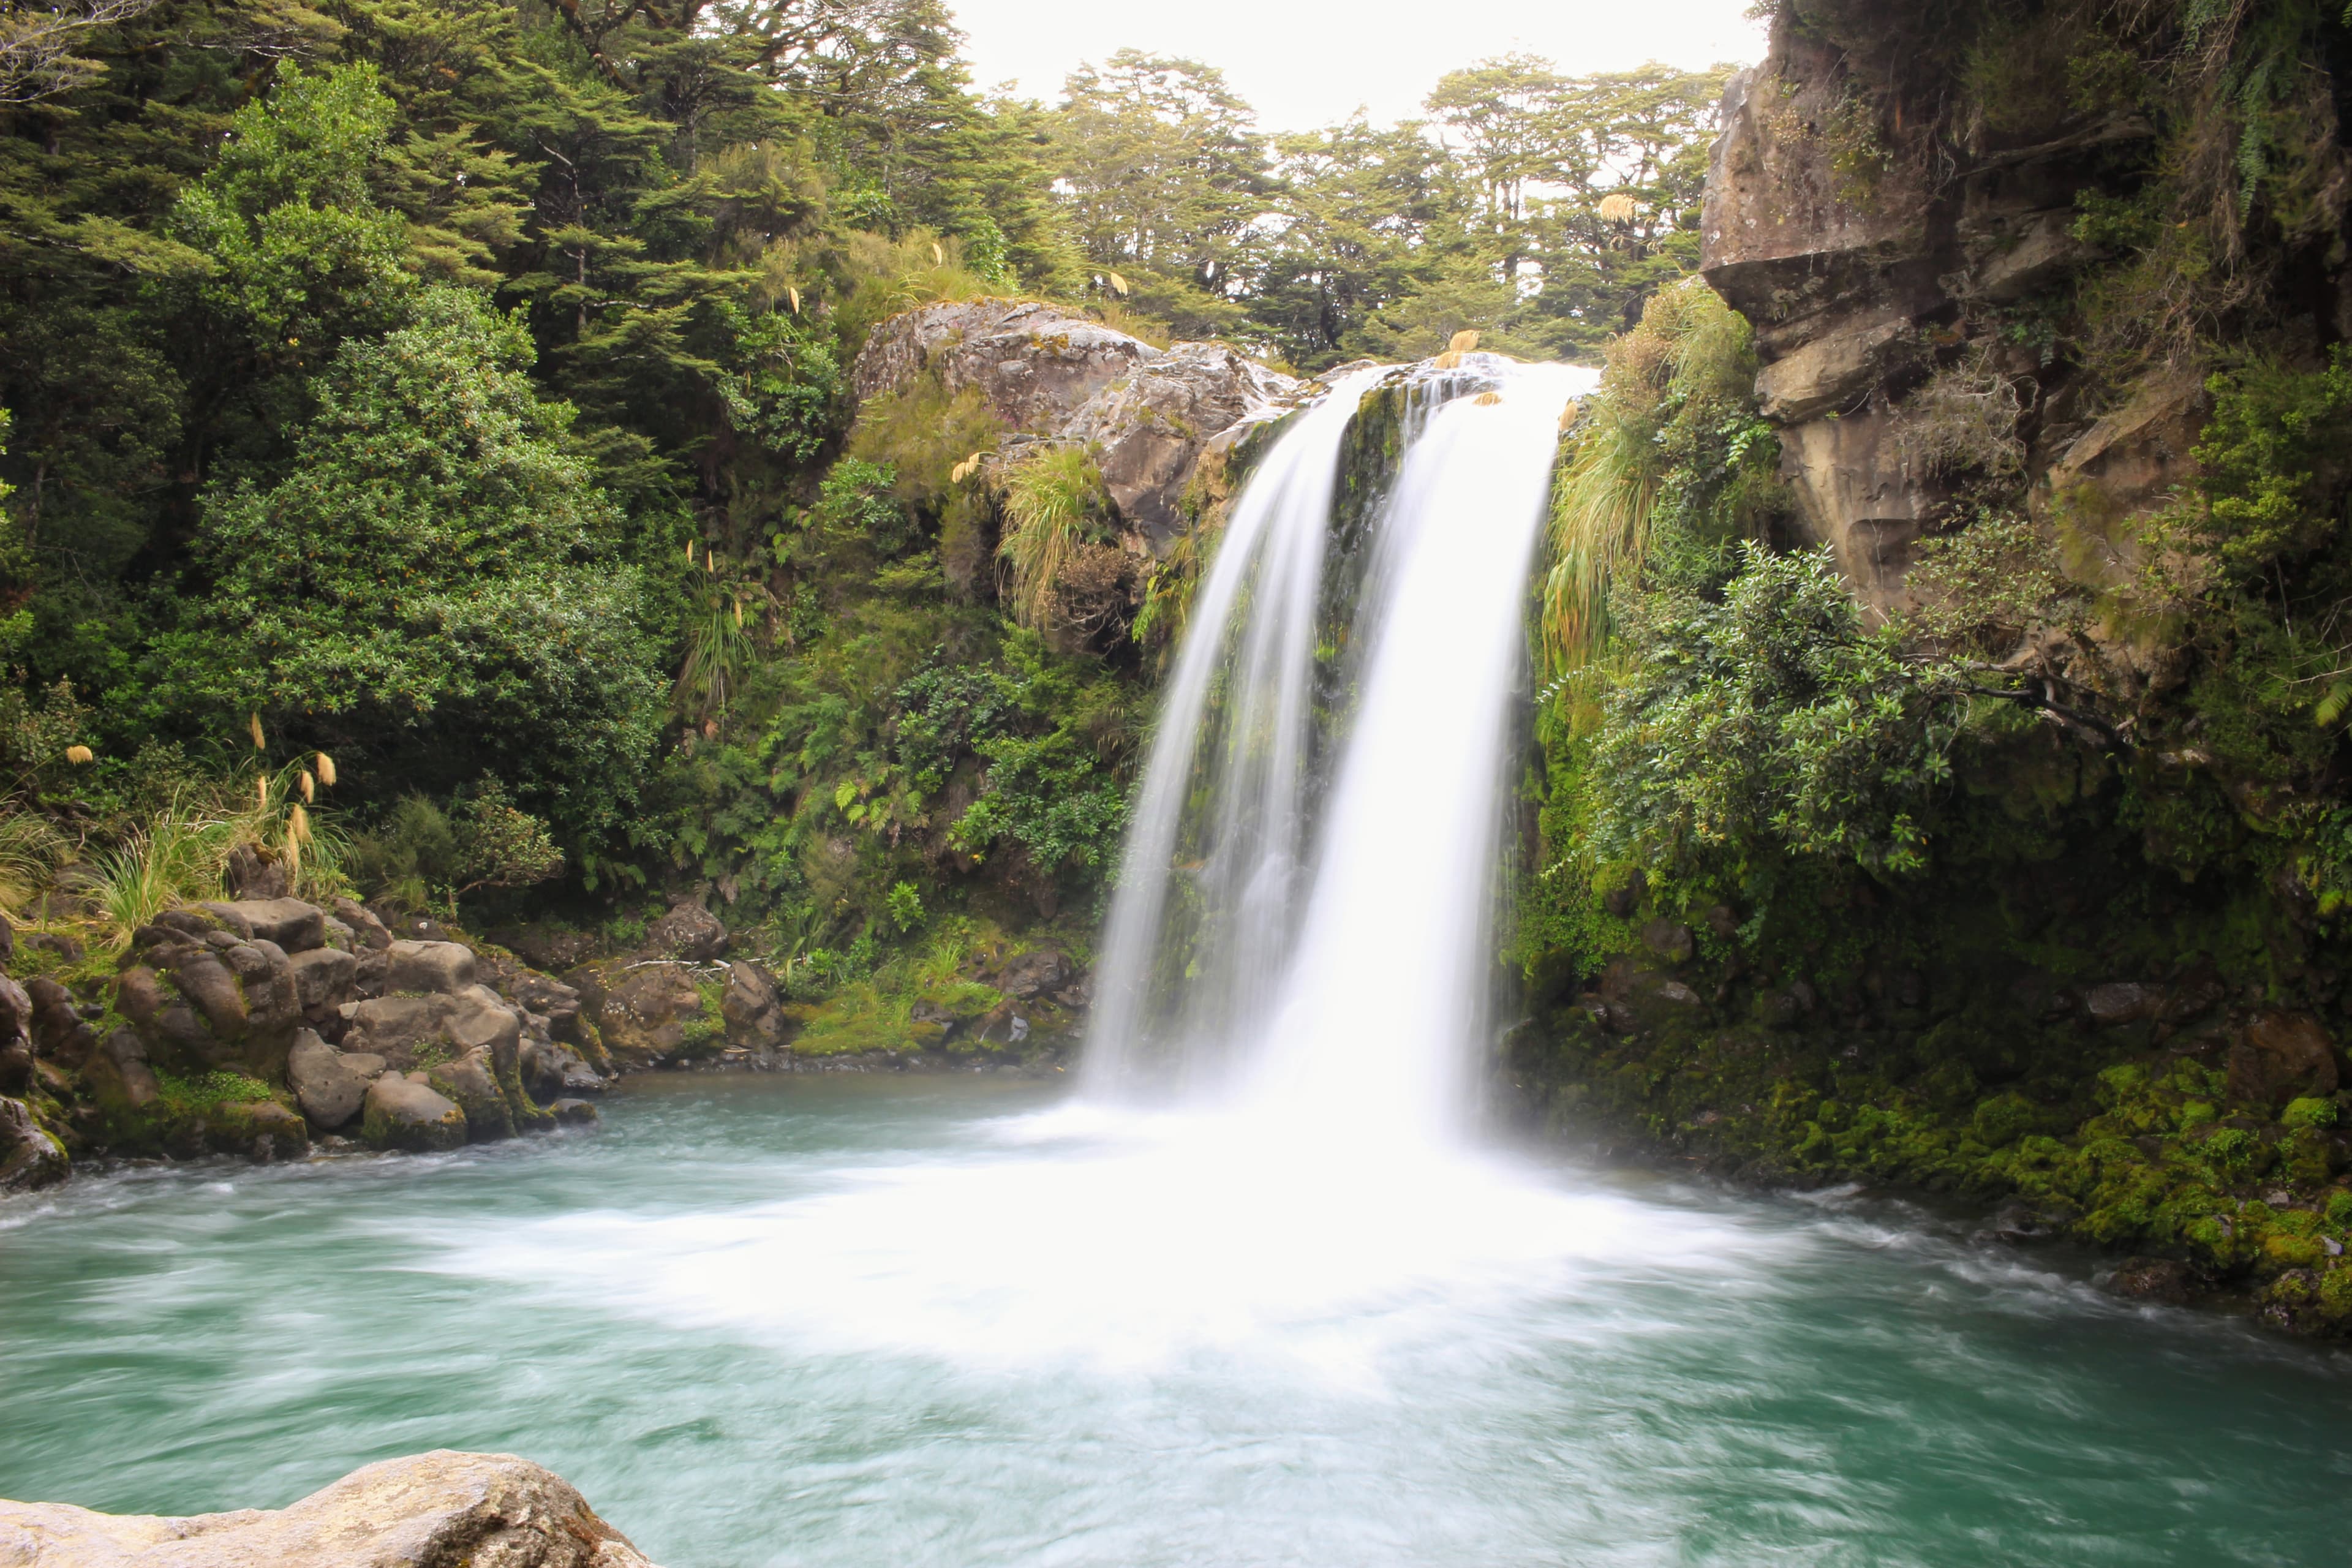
<box><xmin>1700</xmin><ymin>12</ymin><xmax>2173</xmax><ymax>611</ymax></box>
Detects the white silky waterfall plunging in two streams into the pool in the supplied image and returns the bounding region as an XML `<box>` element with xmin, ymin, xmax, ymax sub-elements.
<box><xmin>1087</xmin><ymin>355</ymin><xmax>1590</xmax><ymax>1142</ymax></box>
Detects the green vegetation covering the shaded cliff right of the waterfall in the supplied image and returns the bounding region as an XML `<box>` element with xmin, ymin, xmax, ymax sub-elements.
<box><xmin>1512</xmin><ymin>0</ymin><xmax>2352</xmax><ymax>1333</ymax></box>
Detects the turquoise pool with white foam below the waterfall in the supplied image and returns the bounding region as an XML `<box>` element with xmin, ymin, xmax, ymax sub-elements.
<box><xmin>0</xmin><ymin>1079</ymin><xmax>2352</xmax><ymax>1568</ymax></box>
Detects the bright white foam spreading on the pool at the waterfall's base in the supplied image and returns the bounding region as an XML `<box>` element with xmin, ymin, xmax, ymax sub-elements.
<box><xmin>428</xmin><ymin>1112</ymin><xmax>1787</xmax><ymax>1380</ymax></box>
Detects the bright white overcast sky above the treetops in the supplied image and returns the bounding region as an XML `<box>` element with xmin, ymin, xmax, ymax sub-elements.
<box><xmin>950</xmin><ymin>0</ymin><xmax>1764</xmax><ymax>132</ymax></box>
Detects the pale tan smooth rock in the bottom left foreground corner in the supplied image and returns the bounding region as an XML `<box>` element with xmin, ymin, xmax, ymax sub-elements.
<box><xmin>0</xmin><ymin>1448</ymin><xmax>652</xmax><ymax>1568</ymax></box>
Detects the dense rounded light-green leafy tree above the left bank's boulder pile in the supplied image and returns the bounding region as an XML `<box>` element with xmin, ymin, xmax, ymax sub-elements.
<box><xmin>155</xmin><ymin>287</ymin><xmax>661</xmax><ymax>832</ymax></box>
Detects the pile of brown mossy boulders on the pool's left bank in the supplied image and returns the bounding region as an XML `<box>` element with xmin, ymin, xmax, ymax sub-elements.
<box><xmin>0</xmin><ymin>893</ymin><xmax>611</xmax><ymax>1189</ymax></box>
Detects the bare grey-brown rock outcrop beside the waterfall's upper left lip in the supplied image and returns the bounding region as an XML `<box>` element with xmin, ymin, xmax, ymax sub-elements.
<box><xmin>856</xmin><ymin>298</ymin><xmax>1301</xmax><ymax>555</ymax></box>
